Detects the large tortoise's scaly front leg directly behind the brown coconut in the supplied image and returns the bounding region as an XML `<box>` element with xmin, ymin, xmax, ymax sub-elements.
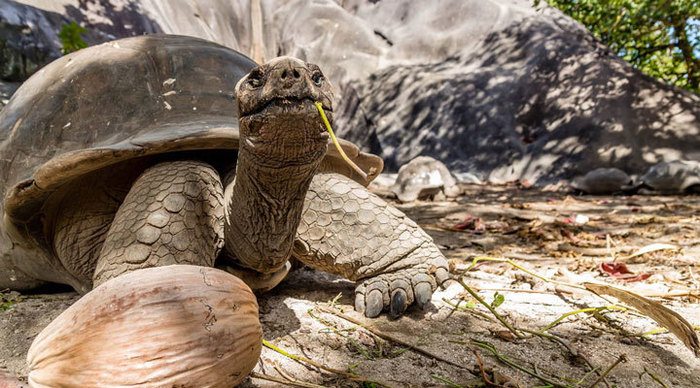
<box><xmin>93</xmin><ymin>161</ymin><xmax>224</xmax><ymax>287</ymax></box>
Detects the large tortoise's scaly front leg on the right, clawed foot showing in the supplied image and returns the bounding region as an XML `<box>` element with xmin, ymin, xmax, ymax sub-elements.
<box><xmin>293</xmin><ymin>174</ymin><xmax>448</xmax><ymax>317</ymax></box>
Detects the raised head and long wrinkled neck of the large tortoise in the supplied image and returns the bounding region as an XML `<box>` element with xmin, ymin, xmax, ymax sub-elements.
<box><xmin>224</xmin><ymin>57</ymin><xmax>333</xmax><ymax>274</ymax></box>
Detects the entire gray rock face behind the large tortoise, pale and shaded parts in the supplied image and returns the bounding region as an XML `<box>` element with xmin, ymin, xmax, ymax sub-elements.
<box><xmin>9</xmin><ymin>0</ymin><xmax>700</xmax><ymax>185</ymax></box>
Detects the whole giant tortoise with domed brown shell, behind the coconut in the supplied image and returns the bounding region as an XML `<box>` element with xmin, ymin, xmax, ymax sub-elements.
<box><xmin>0</xmin><ymin>35</ymin><xmax>448</xmax><ymax>384</ymax></box>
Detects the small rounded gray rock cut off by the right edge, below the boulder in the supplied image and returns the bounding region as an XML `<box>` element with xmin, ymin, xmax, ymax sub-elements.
<box><xmin>640</xmin><ymin>160</ymin><xmax>700</xmax><ymax>193</ymax></box>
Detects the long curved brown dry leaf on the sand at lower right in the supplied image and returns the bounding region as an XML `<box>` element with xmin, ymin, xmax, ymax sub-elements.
<box><xmin>583</xmin><ymin>283</ymin><xmax>700</xmax><ymax>357</ymax></box>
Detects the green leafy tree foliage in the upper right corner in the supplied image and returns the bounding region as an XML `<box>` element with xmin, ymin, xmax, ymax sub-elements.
<box><xmin>535</xmin><ymin>0</ymin><xmax>700</xmax><ymax>93</ymax></box>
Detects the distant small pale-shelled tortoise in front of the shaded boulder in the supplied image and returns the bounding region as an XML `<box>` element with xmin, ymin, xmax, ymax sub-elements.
<box><xmin>391</xmin><ymin>156</ymin><xmax>461</xmax><ymax>202</ymax></box>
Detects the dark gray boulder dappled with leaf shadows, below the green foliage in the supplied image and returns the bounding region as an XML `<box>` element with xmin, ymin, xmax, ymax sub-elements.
<box><xmin>338</xmin><ymin>6</ymin><xmax>700</xmax><ymax>184</ymax></box>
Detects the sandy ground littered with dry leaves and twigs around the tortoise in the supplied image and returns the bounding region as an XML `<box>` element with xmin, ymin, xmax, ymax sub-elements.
<box><xmin>0</xmin><ymin>185</ymin><xmax>700</xmax><ymax>387</ymax></box>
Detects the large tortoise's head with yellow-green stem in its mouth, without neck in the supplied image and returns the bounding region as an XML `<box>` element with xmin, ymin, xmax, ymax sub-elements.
<box><xmin>236</xmin><ymin>57</ymin><xmax>333</xmax><ymax>168</ymax></box>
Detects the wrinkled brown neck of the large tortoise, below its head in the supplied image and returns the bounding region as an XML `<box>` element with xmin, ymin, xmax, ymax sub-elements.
<box><xmin>224</xmin><ymin>147</ymin><xmax>321</xmax><ymax>273</ymax></box>
